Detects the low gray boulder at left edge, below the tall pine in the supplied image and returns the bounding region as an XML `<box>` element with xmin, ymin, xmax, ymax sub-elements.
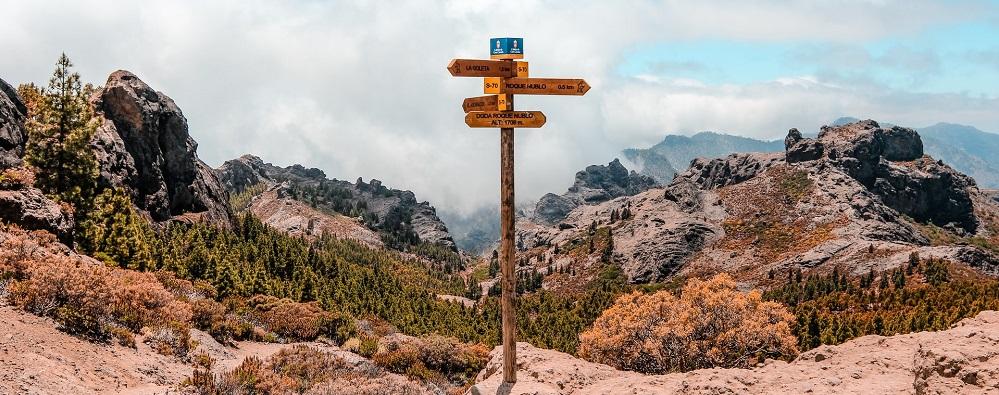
<box><xmin>0</xmin><ymin>188</ymin><xmax>74</xmax><ymax>242</ymax></box>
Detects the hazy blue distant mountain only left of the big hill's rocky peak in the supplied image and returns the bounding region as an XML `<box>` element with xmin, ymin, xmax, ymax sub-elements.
<box><xmin>622</xmin><ymin>132</ymin><xmax>783</xmax><ymax>185</ymax></box>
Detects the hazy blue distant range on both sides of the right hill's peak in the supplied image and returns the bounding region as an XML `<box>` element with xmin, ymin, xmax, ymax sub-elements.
<box><xmin>622</xmin><ymin>117</ymin><xmax>999</xmax><ymax>189</ymax></box>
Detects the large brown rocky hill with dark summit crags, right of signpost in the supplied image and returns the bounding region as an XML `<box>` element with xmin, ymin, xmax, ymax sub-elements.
<box><xmin>518</xmin><ymin>121</ymin><xmax>999</xmax><ymax>284</ymax></box>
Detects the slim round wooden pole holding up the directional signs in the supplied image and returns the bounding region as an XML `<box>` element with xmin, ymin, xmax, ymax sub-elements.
<box><xmin>500</xmin><ymin>76</ymin><xmax>517</xmax><ymax>383</ymax></box>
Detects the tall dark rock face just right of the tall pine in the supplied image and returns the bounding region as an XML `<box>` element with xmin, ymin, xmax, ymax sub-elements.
<box><xmin>92</xmin><ymin>70</ymin><xmax>231</xmax><ymax>226</ymax></box>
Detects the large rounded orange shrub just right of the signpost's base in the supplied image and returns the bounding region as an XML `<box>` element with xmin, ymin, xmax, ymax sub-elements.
<box><xmin>579</xmin><ymin>274</ymin><xmax>798</xmax><ymax>373</ymax></box>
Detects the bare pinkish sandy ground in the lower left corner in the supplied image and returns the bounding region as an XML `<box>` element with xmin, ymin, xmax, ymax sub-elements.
<box><xmin>0</xmin><ymin>305</ymin><xmax>352</xmax><ymax>395</ymax></box>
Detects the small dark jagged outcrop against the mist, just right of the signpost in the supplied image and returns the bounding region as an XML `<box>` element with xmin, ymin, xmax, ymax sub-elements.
<box><xmin>532</xmin><ymin>159</ymin><xmax>658</xmax><ymax>226</ymax></box>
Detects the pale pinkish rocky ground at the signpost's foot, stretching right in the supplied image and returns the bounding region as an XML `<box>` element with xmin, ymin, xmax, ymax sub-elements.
<box><xmin>467</xmin><ymin>311</ymin><xmax>999</xmax><ymax>395</ymax></box>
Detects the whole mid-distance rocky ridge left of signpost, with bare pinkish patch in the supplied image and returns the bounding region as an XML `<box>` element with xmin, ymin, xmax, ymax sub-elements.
<box><xmin>216</xmin><ymin>155</ymin><xmax>455</xmax><ymax>249</ymax></box>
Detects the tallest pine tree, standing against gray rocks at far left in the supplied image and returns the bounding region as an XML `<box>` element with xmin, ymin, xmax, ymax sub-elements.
<box><xmin>25</xmin><ymin>54</ymin><xmax>98</xmax><ymax>212</ymax></box>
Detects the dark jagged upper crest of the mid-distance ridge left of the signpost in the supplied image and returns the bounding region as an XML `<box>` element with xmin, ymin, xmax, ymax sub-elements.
<box><xmin>216</xmin><ymin>155</ymin><xmax>456</xmax><ymax>248</ymax></box>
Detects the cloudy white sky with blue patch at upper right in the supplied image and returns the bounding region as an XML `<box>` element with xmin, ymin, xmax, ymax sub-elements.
<box><xmin>0</xmin><ymin>0</ymin><xmax>999</xmax><ymax>215</ymax></box>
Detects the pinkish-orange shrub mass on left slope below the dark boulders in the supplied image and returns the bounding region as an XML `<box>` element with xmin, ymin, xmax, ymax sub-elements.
<box><xmin>0</xmin><ymin>229</ymin><xmax>191</xmax><ymax>354</ymax></box>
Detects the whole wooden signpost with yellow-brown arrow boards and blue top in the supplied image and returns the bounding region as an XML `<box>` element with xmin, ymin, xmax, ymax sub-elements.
<box><xmin>447</xmin><ymin>38</ymin><xmax>590</xmax><ymax>383</ymax></box>
